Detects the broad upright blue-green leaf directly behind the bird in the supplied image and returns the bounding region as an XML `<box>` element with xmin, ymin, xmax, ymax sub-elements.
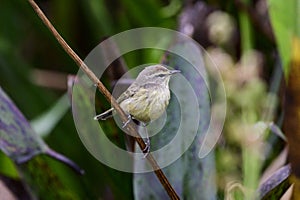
<box><xmin>134</xmin><ymin>38</ymin><xmax>216</xmax><ymax>200</ymax></box>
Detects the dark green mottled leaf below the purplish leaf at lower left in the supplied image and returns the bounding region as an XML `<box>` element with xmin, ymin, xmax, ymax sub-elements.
<box><xmin>17</xmin><ymin>154</ymin><xmax>89</xmax><ymax>200</ymax></box>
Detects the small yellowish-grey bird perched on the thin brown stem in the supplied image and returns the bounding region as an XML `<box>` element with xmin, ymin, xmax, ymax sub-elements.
<box><xmin>94</xmin><ymin>65</ymin><xmax>180</xmax><ymax>123</ymax></box>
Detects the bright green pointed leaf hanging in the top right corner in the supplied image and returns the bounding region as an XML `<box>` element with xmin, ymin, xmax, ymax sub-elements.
<box><xmin>268</xmin><ymin>0</ymin><xmax>300</xmax><ymax>78</ymax></box>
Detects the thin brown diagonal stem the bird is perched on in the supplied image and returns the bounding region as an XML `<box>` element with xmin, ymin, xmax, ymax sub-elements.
<box><xmin>28</xmin><ymin>0</ymin><xmax>179</xmax><ymax>199</ymax></box>
